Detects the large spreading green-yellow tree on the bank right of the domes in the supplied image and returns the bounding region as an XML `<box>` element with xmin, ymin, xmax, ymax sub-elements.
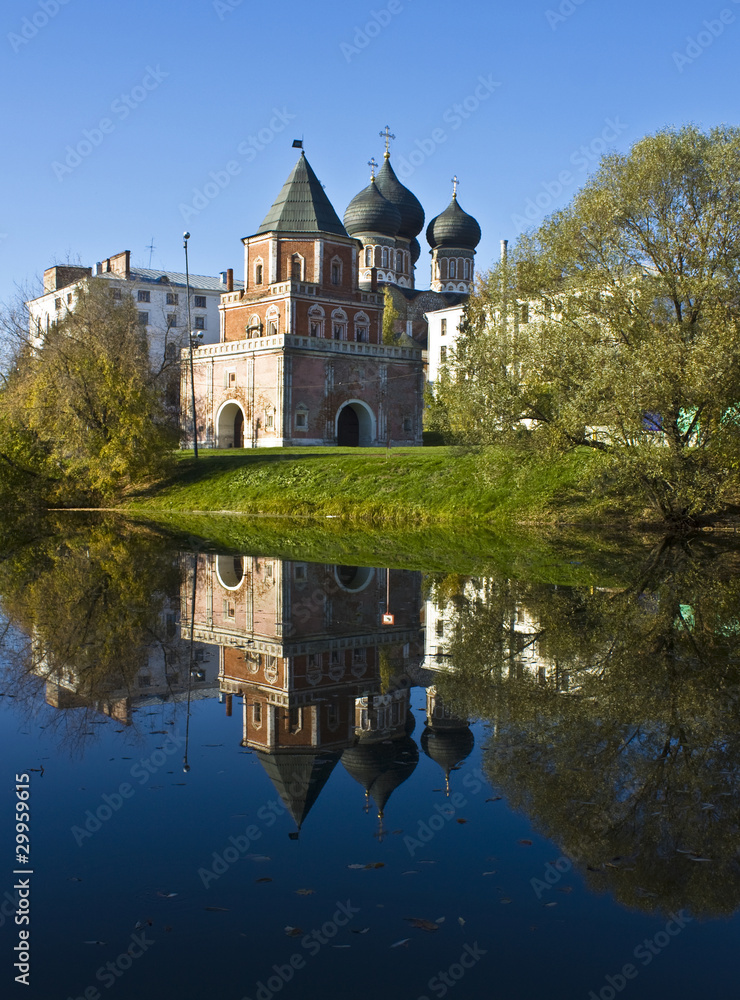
<box><xmin>437</xmin><ymin>126</ymin><xmax>740</xmax><ymax>525</ymax></box>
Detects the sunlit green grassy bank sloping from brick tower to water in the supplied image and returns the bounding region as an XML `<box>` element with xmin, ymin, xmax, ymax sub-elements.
<box><xmin>125</xmin><ymin>447</ymin><xmax>627</xmax><ymax>524</ymax></box>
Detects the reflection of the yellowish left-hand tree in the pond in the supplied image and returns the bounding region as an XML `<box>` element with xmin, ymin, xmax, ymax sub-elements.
<box><xmin>0</xmin><ymin>521</ymin><xmax>180</xmax><ymax>742</ymax></box>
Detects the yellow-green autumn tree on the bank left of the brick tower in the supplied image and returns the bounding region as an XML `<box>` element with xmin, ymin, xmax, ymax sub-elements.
<box><xmin>0</xmin><ymin>279</ymin><xmax>174</xmax><ymax>504</ymax></box>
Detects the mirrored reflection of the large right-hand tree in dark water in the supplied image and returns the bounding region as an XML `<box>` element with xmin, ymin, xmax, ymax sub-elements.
<box><xmin>439</xmin><ymin>538</ymin><xmax>740</xmax><ymax>914</ymax></box>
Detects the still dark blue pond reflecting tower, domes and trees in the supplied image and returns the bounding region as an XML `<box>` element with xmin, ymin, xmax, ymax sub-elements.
<box><xmin>0</xmin><ymin>521</ymin><xmax>740</xmax><ymax>1000</ymax></box>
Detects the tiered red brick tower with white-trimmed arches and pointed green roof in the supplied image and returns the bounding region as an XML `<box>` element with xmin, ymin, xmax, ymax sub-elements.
<box><xmin>181</xmin><ymin>153</ymin><xmax>424</xmax><ymax>448</ymax></box>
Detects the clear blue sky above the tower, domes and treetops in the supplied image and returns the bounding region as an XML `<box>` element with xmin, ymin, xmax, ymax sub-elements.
<box><xmin>0</xmin><ymin>0</ymin><xmax>740</xmax><ymax>301</ymax></box>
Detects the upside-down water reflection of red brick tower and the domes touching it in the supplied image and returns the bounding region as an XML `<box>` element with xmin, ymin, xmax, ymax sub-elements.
<box><xmin>182</xmin><ymin>555</ymin><xmax>422</xmax><ymax>829</ymax></box>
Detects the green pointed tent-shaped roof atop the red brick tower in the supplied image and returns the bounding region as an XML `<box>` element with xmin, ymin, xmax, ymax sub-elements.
<box><xmin>256</xmin><ymin>153</ymin><xmax>347</xmax><ymax>236</ymax></box>
